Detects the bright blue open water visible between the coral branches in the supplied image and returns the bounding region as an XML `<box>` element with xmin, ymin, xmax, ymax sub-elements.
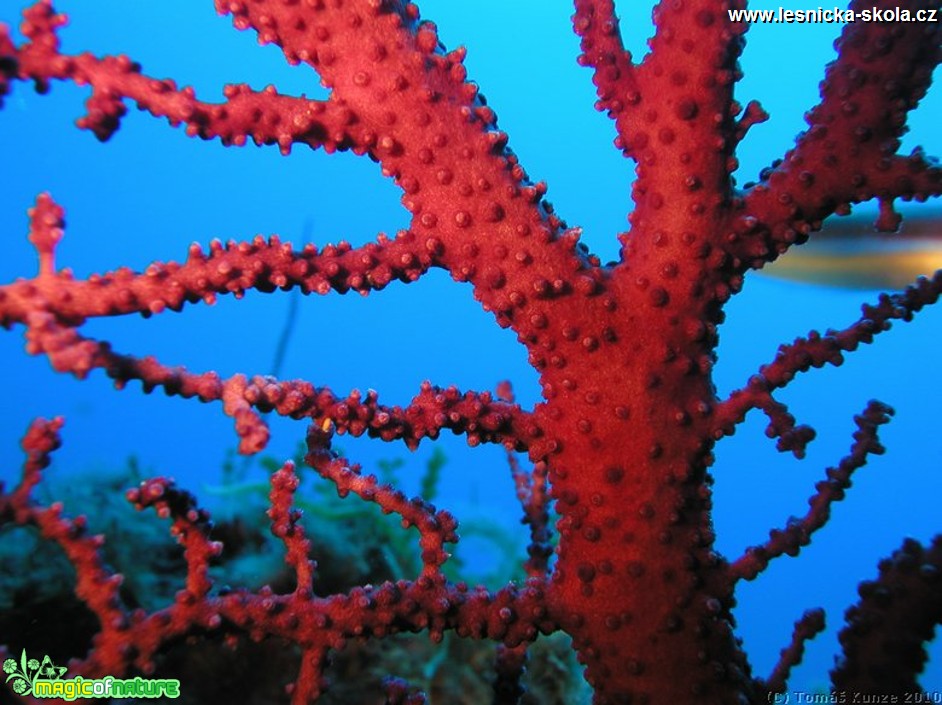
<box><xmin>0</xmin><ymin>0</ymin><xmax>942</xmax><ymax>691</ymax></box>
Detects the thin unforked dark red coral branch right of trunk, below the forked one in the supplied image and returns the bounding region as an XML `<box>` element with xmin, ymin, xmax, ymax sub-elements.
<box><xmin>729</xmin><ymin>401</ymin><xmax>893</xmax><ymax>580</ymax></box>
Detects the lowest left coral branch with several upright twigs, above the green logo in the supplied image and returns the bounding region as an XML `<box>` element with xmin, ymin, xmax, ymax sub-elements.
<box><xmin>0</xmin><ymin>420</ymin><xmax>554</xmax><ymax>705</ymax></box>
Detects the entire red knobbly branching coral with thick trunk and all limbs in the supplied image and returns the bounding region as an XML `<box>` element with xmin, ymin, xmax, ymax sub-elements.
<box><xmin>0</xmin><ymin>0</ymin><xmax>942</xmax><ymax>705</ymax></box>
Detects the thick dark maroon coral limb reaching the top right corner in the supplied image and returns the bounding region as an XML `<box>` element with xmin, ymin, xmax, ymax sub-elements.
<box><xmin>729</xmin><ymin>0</ymin><xmax>942</xmax><ymax>268</ymax></box>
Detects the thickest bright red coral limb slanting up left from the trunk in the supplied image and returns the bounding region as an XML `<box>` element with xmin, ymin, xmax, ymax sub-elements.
<box><xmin>217</xmin><ymin>0</ymin><xmax>600</xmax><ymax>346</ymax></box>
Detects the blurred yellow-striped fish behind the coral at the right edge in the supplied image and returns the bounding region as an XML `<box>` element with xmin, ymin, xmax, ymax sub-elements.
<box><xmin>760</xmin><ymin>213</ymin><xmax>942</xmax><ymax>291</ymax></box>
